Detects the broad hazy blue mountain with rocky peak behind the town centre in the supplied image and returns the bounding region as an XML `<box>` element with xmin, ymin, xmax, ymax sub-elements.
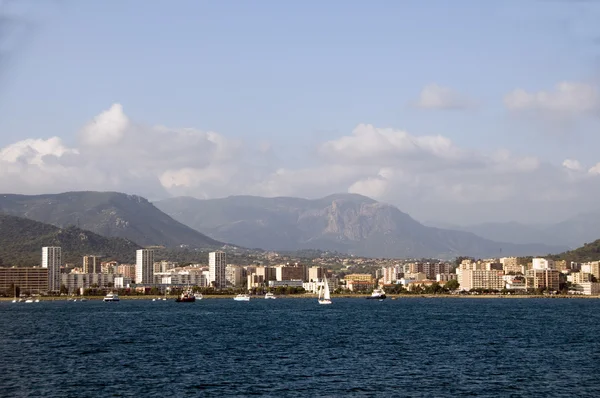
<box><xmin>155</xmin><ymin>194</ymin><xmax>566</xmax><ymax>258</ymax></box>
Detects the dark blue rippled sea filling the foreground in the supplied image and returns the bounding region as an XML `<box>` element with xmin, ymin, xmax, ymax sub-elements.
<box><xmin>0</xmin><ymin>298</ymin><xmax>600</xmax><ymax>397</ymax></box>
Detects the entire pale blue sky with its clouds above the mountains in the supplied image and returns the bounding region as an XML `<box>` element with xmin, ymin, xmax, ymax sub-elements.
<box><xmin>0</xmin><ymin>0</ymin><xmax>600</xmax><ymax>225</ymax></box>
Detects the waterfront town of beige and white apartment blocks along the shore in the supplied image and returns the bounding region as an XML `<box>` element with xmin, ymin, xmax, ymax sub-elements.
<box><xmin>0</xmin><ymin>246</ymin><xmax>600</xmax><ymax>297</ymax></box>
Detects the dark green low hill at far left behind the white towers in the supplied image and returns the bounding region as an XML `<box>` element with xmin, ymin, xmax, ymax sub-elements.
<box><xmin>0</xmin><ymin>214</ymin><xmax>141</xmax><ymax>266</ymax></box>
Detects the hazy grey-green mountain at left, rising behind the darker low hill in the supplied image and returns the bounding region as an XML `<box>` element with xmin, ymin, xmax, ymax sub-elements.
<box><xmin>0</xmin><ymin>192</ymin><xmax>223</xmax><ymax>248</ymax></box>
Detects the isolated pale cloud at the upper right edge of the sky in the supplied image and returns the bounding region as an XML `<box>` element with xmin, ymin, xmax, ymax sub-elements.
<box><xmin>504</xmin><ymin>82</ymin><xmax>600</xmax><ymax>116</ymax></box>
